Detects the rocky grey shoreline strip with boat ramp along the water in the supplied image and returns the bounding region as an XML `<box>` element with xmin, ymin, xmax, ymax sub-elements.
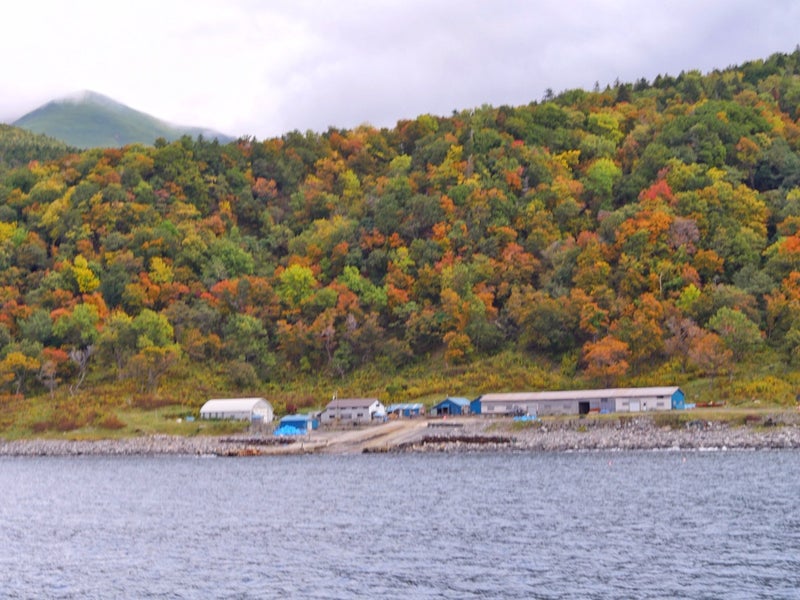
<box><xmin>0</xmin><ymin>417</ymin><xmax>800</xmax><ymax>457</ymax></box>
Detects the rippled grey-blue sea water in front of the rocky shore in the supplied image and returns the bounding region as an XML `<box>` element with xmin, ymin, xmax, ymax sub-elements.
<box><xmin>0</xmin><ymin>451</ymin><xmax>800</xmax><ymax>600</ymax></box>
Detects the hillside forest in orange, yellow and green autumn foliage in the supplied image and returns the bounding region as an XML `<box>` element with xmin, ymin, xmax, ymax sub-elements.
<box><xmin>0</xmin><ymin>50</ymin><xmax>800</xmax><ymax>426</ymax></box>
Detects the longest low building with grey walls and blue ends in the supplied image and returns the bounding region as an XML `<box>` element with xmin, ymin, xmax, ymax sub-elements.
<box><xmin>471</xmin><ymin>386</ymin><xmax>685</xmax><ymax>416</ymax></box>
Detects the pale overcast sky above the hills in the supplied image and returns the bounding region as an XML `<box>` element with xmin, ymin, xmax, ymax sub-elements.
<box><xmin>0</xmin><ymin>0</ymin><xmax>800</xmax><ymax>139</ymax></box>
